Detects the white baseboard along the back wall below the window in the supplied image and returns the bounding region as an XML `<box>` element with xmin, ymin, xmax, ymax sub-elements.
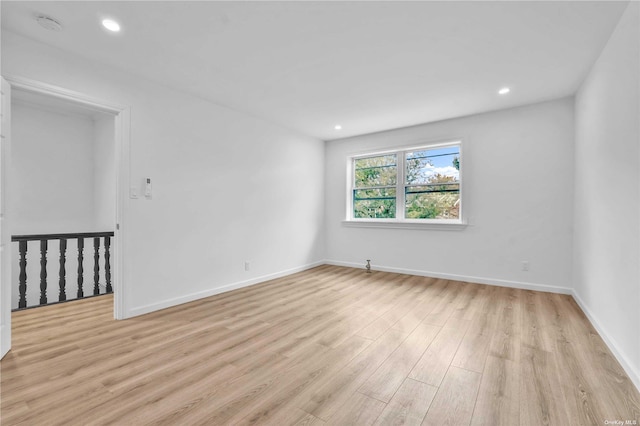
<box><xmin>325</xmin><ymin>260</ymin><xmax>572</xmax><ymax>294</ymax></box>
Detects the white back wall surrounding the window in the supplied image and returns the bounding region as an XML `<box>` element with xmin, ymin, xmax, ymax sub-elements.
<box><xmin>325</xmin><ymin>98</ymin><xmax>573</xmax><ymax>292</ymax></box>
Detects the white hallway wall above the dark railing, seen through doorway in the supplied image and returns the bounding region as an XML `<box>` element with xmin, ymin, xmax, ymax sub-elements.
<box><xmin>9</xmin><ymin>102</ymin><xmax>94</xmax><ymax>235</ymax></box>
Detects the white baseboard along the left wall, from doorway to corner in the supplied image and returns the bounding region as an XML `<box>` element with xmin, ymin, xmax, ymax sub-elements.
<box><xmin>125</xmin><ymin>261</ymin><xmax>325</xmax><ymax>318</ymax></box>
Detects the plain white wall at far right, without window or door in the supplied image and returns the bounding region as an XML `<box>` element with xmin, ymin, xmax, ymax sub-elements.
<box><xmin>573</xmin><ymin>2</ymin><xmax>640</xmax><ymax>388</ymax></box>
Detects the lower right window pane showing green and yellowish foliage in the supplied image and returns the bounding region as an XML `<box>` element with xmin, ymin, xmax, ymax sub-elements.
<box><xmin>405</xmin><ymin>185</ymin><xmax>460</xmax><ymax>219</ymax></box>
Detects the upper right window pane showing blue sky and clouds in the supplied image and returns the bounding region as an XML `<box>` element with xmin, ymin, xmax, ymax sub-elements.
<box><xmin>405</xmin><ymin>146</ymin><xmax>460</xmax><ymax>185</ymax></box>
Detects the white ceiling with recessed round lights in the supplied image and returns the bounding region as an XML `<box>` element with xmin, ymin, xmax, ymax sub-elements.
<box><xmin>1</xmin><ymin>1</ymin><xmax>627</xmax><ymax>140</ymax></box>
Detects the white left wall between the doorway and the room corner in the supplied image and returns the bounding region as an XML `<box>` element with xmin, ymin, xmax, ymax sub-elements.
<box><xmin>2</xmin><ymin>33</ymin><xmax>324</xmax><ymax>316</ymax></box>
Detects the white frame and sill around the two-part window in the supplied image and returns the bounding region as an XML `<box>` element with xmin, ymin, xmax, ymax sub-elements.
<box><xmin>342</xmin><ymin>139</ymin><xmax>467</xmax><ymax>230</ymax></box>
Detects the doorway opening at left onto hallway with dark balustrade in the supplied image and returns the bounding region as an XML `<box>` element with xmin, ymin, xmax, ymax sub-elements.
<box><xmin>8</xmin><ymin>89</ymin><xmax>116</xmax><ymax>311</ymax></box>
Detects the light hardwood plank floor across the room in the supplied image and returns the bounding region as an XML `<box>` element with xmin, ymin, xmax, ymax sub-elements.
<box><xmin>0</xmin><ymin>266</ymin><xmax>640</xmax><ymax>426</ymax></box>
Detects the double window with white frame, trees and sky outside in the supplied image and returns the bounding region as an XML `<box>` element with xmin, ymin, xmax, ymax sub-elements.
<box><xmin>348</xmin><ymin>142</ymin><xmax>462</xmax><ymax>223</ymax></box>
